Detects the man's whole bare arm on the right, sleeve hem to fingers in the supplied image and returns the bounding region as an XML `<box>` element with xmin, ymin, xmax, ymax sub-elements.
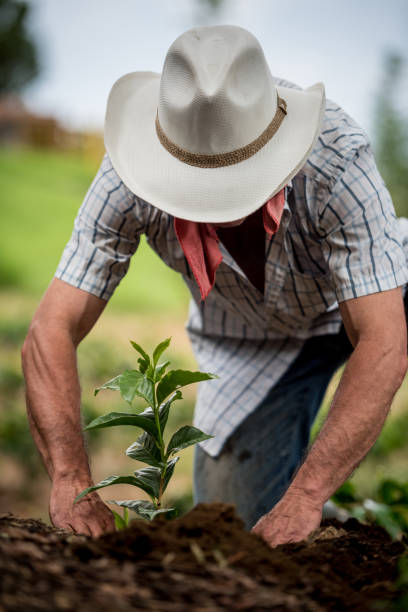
<box><xmin>253</xmin><ymin>288</ymin><xmax>407</xmax><ymax>546</ymax></box>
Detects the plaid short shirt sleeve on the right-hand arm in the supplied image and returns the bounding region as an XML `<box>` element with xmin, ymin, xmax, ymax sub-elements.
<box><xmin>319</xmin><ymin>145</ymin><xmax>408</xmax><ymax>302</ymax></box>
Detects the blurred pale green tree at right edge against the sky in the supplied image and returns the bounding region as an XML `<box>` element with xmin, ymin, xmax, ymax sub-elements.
<box><xmin>374</xmin><ymin>53</ymin><xmax>408</xmax><ymax>217</ymax></box>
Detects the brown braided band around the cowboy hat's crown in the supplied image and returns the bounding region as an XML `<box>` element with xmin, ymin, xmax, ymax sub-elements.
<box><xmin>156</xmin><ymin>94</ymin><xmax>287</xmax><ymax>168</ymax></box>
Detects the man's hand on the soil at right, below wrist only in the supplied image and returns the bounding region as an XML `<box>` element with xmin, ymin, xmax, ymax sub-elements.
<box><xmin>252</xmin><ymin>489</ymin><xmax>323</xmax><ymax>547</ymax></box>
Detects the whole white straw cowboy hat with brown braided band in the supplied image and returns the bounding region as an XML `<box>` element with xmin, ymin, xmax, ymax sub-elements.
<box><xmin>105</xmin><ymin>26</ymin><xmax>325</xmax><ymax>223</ymax></box>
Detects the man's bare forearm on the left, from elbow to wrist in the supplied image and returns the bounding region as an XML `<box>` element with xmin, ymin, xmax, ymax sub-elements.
<box><xmin>22</xmin><ymin>324</ymin><xmax>90</xmax><ymax>482</ymax></box>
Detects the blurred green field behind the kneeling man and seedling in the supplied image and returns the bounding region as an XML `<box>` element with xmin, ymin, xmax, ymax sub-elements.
<box><xmin>0</xmin><ymin>149</ymin><xmax>408</xmax><ymax>521</ymax></box>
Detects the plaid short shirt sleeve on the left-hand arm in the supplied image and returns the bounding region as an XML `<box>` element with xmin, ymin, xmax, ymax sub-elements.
<box><xmin>55</xmin><ymin>155</ymin><xmax>147</xmax><ymax>300</ymax></box>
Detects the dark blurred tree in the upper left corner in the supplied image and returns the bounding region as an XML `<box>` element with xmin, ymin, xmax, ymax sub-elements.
<box><xmin>0</xmin><ymin>0</ymin><xmax>39</xmax><ymax>96</ymax></box>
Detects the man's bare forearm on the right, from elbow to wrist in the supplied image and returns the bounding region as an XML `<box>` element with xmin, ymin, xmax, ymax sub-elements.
<box><xmin>289</xmin><ymin>343</ymin><xmax>406</xmax><ymax>503</ymax></box>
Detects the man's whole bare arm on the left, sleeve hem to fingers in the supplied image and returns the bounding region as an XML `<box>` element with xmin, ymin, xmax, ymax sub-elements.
<box><xmin>22</xmin><ymin>278</ymin><xmax>115</xmax><ymax>536</ymax></box>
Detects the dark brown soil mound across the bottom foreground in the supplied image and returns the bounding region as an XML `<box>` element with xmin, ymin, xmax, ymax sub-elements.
<box><xmin>0</xmin><ymin>504</ymin><xmax>404</xmax><ymax>612</ymax></box>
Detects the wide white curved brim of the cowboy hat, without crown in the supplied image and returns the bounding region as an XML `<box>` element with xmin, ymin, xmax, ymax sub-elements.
<box><xmin>105</xmin><ymin>72</ymin><xmax>325</xmax><ymax>223</ymax></box>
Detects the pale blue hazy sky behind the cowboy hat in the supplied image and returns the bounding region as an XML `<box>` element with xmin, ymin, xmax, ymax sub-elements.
<box><xmin>24</xmin><ymin>0</ymin><xmax>408</xmax><ymax>140</ymax></box>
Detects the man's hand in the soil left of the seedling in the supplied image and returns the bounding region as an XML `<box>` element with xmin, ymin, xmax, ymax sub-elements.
<box><xmin>49</xmin><ymin>477</ymin><xmax>115</xmax><ymax>537</ymax></box>
